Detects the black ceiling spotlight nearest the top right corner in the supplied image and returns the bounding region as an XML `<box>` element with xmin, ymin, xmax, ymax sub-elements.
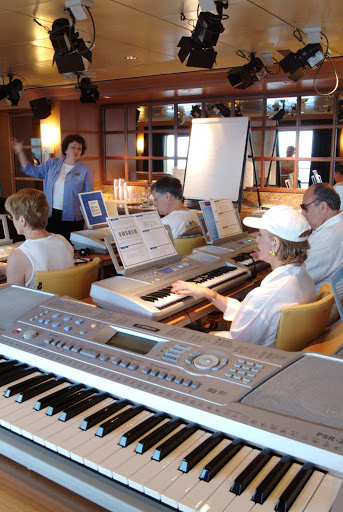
<box><xmin>279</xmin><ymin>43</ymin><xmax>324</xmax><ymax>82</ymax></box>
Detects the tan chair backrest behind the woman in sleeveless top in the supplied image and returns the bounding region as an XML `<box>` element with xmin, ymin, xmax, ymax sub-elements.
<box><xmin>36</xmin><ymin>258</ymin><xmax>100</xmax><ymax>299</ymax></box>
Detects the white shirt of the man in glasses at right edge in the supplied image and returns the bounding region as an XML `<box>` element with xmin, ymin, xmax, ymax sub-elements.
<box><xmin>305</xmin><ymin>212</ymin><xmax>343</xmax><ymax>325</ymax></box>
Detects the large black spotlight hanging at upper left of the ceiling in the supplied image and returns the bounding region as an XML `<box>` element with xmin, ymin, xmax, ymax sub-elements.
<box><xmin>49</xmin><ymin>14</ymin><xmax>92</xmax><ymax>74</ymax></box>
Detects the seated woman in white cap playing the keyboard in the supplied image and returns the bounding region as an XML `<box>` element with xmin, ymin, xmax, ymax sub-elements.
<box><xmin>171</xmin><ymin>205</ymin><xmax>317</xmax><ymax>346</ymax></box>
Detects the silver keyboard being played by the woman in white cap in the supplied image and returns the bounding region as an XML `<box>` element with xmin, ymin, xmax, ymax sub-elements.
<box><xmin>90</xmin><ymin>253</ymin><xmax>251</xmax><ymax>320</ymax></box>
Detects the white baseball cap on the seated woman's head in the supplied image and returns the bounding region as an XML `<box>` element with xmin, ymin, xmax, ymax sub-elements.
<box><xmin>243</xmin><ymin>205</ymin><xmax>311</xmax><ymax>242</ymax></box>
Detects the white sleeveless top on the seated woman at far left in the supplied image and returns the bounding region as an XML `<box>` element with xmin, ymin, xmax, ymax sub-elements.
<box><xmin>15</xmin><ymin>234</ymin><xmax>74</xmax><ymax>288</ymax></box>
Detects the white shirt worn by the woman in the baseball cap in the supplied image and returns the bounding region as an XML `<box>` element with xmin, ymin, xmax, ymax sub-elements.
<box><xmin>215</xmin><ymin>264</ymin><xmax>317</xmax><ymax>346</ymax></box>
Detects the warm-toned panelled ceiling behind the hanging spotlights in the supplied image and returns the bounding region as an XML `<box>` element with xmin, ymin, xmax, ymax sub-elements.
<box><xmin>0</xmin><ymin>0</ymin><xmax>343</xmax><ymax>97</ymax></box>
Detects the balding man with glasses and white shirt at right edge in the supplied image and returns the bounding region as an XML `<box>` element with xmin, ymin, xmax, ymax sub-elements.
<box><xmin>300</xmin><ymin>183</ymin><xmax>343</xmax><ymax>324</ymax></box>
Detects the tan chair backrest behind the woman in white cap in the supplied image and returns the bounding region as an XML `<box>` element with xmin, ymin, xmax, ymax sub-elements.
<box><xmin>275</xmin><ymin>283</ymin><xmax>335</xmax><ymax>352</ymax></box>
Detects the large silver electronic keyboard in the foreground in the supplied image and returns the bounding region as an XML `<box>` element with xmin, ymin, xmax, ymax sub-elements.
<box><xmin>0</xmin><ymin>292</ymin><xmax>343</xmax><ymax>512</ymax></box>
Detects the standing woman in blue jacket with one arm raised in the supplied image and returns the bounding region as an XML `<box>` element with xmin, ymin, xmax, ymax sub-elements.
<box><xmin>12</xmin><ymin>135</ymin><xmax>94</xmax><ymax>240</ymax></box>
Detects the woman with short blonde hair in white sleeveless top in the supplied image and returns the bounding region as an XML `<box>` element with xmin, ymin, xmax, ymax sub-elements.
<box><xmin>3</xmin><ymin>188</ymin><xmax>74</xmax><ymax>288</ymax></box>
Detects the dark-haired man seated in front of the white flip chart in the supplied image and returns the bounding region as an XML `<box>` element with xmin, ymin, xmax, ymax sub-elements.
<box><xmin>151</xmin><ymin>176</ymin><xmax>202</xmax><ymax>238</ymax></box>
